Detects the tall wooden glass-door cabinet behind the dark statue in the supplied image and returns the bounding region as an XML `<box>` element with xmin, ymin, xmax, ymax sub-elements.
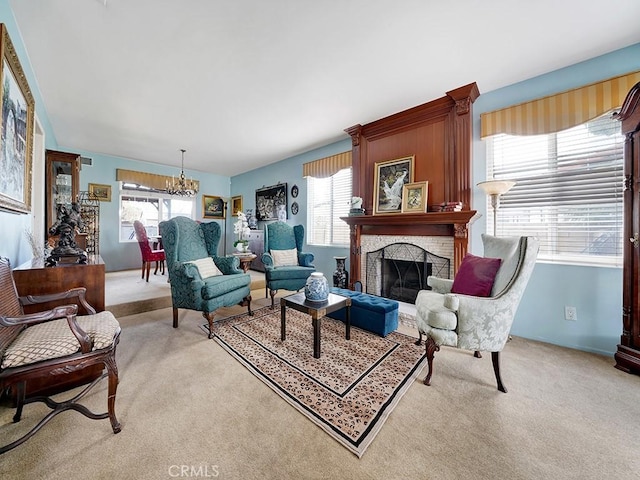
<box><xmin>45</xmin><ymin>150</ymin><xmax>80</xmax><ymax>232</ymax></box>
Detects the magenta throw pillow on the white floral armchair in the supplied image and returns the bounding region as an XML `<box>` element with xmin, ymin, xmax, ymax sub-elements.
<box><xmin>451</xmin><ymin>253</ymin><xmax>501</xmax><ymax>297</ymax></box>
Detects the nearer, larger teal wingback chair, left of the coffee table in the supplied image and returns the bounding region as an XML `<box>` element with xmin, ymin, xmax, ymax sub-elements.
<box><xmin>160</xmin><ymin>217</ymin><xmax>253</xmax><ymax>338</ymax></box>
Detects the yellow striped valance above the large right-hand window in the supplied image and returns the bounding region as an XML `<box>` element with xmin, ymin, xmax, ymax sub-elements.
<box><xmin>480</xmin><ymin>72</ymin><xmax>640</xmax><ymax>138</ymax></box>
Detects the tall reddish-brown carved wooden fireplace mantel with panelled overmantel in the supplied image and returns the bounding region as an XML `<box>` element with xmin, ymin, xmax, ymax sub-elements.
<box><xmin>342</xmin><ymin>83</ymin><xmax>480</xmax><ymax>282</ymax></box>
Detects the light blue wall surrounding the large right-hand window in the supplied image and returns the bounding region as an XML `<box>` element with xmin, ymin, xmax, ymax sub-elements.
<box><xmin>471</xmin><ymin>44</ymin><xmax>640</xmax><ymax>355</ymax></box>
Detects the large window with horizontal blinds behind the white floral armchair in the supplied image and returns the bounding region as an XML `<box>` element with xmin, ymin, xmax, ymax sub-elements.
<box><xmin>487</xmin><ymin>113</ymin><xmax>624</xmax><ymax>266</ymax></box>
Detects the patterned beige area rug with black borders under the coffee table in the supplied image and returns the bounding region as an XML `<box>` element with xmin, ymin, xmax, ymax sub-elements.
<box><xmin>203</xmin><ymin>307</ymin><xmax>426</xmax><ymax>457</ymax></box>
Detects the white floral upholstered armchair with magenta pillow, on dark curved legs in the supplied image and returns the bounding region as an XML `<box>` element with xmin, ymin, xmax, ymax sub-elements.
<box><xmin>416</xmin><ymin>234</ymin><xmax>538</xmax><ymax>393</ymax></box>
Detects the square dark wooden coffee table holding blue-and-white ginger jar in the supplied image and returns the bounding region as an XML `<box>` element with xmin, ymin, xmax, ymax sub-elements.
<box><xmin>280</xmin><ymin>292</ymin><xmax>351</xmax><ymax>358</ymax></box>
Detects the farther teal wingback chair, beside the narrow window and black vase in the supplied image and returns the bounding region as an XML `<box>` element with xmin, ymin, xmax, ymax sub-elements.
<box><xmin>262</xmin><ymin>222</ymin><xmax>316</xmax><ymax>308</ymax></box>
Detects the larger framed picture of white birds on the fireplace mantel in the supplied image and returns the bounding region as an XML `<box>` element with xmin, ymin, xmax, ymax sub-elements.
<box><xmin>373</xmin><ymin>155</ymin><xmax>414</xmax><ymax>215</ymax></box>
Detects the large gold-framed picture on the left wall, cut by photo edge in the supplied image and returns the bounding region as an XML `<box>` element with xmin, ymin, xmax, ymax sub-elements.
<box><xmin>0</xmin><ymin>23</ymin><xmax>34</xmax><ymax>213</ymax></box>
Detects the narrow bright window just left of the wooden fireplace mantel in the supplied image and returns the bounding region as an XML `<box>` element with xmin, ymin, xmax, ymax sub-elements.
<box><xmin>307</xmin><ymin>168</ymin><xmax>351</xmax><ymax>247</ymax></box>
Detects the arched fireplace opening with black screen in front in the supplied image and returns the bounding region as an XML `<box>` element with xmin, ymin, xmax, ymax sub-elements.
<box><xmin>366</xmin><ymin>243</ymin><xmax>451</xmax><ymax>303</ymax></box>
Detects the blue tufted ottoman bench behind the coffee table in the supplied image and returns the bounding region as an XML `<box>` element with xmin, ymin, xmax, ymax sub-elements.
<box><xmin>328</xmin><ymin>287</ymin><xmax>398</xmax><ymax>337</ymax></box>
